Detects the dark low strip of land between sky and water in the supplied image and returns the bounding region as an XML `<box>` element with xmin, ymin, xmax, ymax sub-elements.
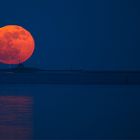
<box><xmin>0</xmin><ymin>66</ymin><xmax>140</xmax><ymax>85</ymax></box>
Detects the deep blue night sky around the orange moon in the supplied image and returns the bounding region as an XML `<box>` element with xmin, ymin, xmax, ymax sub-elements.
<box><xmin>0</xmin><ymin>0</ymin><xmax>140</xmax><ymax>70</ymax></box>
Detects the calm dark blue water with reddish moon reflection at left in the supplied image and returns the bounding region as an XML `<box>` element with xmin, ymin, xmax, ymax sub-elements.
<box><xmin>0</xmin><ymin>85</ymin><xmax>140</xmax><ymax>140</ymax></box>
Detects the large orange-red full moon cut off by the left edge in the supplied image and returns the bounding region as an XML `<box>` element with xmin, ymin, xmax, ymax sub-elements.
<box><xmin>0</xmin><ymin>25</ymin><xmax>35</xmax><ymax>64</ymax></box>
